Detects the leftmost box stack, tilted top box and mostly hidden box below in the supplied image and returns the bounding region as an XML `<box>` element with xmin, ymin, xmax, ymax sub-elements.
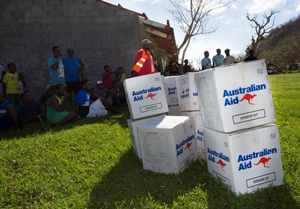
<box><xmin>124</xmin><ymin>73</ymin><xmax>169</xmax><ymax>159</ymax></box>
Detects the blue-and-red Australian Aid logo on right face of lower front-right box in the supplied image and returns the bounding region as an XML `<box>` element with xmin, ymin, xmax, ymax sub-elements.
<box><xmin>237</xmin><ymin>148</ymin><xmax>277</xmax><ymax>171</ymax></box>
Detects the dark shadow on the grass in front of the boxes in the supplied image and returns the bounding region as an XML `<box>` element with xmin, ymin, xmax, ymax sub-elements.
<box><xmin>89</xmin><ymin>151</ymin><xmax>299</xmax><ymax>209</ymax></box>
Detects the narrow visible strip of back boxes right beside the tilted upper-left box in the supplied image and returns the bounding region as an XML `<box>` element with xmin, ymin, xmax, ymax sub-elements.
<box><xmin>164</xmin><ymin>76</ymin><xmax>180</xmax><ymax>116</ymax></box>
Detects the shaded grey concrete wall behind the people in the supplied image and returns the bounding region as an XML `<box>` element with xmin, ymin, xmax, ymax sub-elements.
<box><xmin>0</xmin><ymin>0</ymin><xmax>140</xmax><ymax>98</ymax></box>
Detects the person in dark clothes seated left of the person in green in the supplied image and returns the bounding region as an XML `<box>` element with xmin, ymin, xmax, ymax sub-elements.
<box><xmin>17</xmin><ymin>90</ymin><xmax>46</xmax><ymax>123</ymax></box>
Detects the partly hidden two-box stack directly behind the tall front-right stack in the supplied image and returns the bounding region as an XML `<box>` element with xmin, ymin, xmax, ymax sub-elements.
<box><xmin>178</xmin><ymin>73</ymin><xmax>206</xmax><ymax>160</ymax></box>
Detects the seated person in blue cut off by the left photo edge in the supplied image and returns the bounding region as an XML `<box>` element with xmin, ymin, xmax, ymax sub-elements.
<box><xmin>0</xmin><ymin>92</ymin><xmax>21</xmax><ymax>130</ymax></box>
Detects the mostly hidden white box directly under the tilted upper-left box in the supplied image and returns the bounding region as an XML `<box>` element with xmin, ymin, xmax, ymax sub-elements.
<box><xmin>127</xmin><ymin>115</ymin><xmax>165</xmax><ymax>159</ymax></box>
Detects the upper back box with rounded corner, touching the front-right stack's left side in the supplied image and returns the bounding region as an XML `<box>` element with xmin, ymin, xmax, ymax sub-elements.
<box><xmin>178</xmin><ymin>72</ymin><xmax>199</xmax><ymax>111</ymax></box>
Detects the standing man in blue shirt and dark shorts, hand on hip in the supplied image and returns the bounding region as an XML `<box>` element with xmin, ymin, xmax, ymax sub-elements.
<box><xmin>63</xmin><ymin>48</ymin><xmax>84</xmax><ymax>104</ymax></box>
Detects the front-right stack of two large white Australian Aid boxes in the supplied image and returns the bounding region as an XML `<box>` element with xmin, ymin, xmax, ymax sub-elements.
<box><xmin>195</xmin><ymin>60</ymin><xmax>283</xmax><ymax>194</ymax></box>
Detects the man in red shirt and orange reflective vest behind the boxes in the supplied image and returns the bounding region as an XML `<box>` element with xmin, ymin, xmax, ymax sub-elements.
<box><xmin>135</xmin><ymin>39</ymin><xmax>155</xmax><ymax>76</ymax></box>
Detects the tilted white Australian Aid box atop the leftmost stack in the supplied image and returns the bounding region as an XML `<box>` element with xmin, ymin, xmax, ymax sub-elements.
<box><xmin>124</xmin><ymin>73</ymin><xmax>169</xmax><ymax>119</ymax></box>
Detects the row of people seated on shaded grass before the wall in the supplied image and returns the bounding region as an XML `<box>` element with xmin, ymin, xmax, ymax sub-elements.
<box><xmin>0</xmin><ymin>79</ymin><xmax>125</xmax><ymax>130</ymax></box>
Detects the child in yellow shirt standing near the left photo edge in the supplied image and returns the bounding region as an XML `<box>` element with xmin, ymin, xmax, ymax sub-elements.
<box><xmin>2</xmin><ymin>63</ymin><xmax>19</xmax><ymax>107</ymax></box>
